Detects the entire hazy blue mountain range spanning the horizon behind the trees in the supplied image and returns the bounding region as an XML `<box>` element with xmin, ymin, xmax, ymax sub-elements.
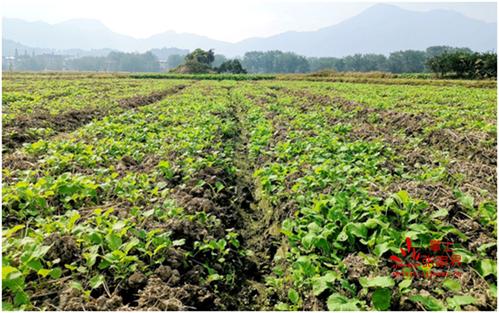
<box><xmin>2</xmin><ymin>4</ymin><xmax>496</xmax><ymax>56</ymax></box>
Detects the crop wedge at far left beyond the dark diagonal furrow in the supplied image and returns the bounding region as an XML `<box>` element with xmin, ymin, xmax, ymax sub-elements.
<box><xmin>2</xmin><ymin>78</ymin><xmax>186</xmax><ymax>151</ymax></box>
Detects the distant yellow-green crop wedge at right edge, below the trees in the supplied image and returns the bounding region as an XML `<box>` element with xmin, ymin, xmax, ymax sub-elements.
<box><xmin>264</xmin><ymin>82</ymin><xmax>497</xmax><ymax>134</ymax></box>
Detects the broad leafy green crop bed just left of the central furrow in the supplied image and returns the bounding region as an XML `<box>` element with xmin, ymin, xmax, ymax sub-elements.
<box><xmin>2</xmin><ymin>81</ymin><xmax>254</xmax><ymax>310</ymax></box>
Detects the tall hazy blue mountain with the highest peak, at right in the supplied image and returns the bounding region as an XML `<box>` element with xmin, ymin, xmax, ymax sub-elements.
<box><xmin>229</xmin><ymin>4</ymin><xmax>496</xmax><ymax>56</ymax></box>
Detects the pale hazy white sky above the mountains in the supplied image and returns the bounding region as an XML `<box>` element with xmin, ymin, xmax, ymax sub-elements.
<box><xmin>2</xmin><ymin>0</ymin><xmax>497</xmax><ymax>42</ymax></box>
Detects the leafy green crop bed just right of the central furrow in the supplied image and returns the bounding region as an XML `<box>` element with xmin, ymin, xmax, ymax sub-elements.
<box><xmin>232</xmin><ymin>83</ymin><xmax>496</xmax><ymax>310</ymax></box>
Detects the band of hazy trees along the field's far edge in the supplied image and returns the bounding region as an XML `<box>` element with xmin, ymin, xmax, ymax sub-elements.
<box><xmin>2</xmin><ymin>46</ymin><xmax>497</xmax><ymax>79</ymax></box>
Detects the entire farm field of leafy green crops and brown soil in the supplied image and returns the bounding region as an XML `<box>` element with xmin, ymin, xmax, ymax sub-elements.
<box><xmin>2</xmin><ymin>73</ymin><xmax>497</xmax><ymax>311</ymax></box>
